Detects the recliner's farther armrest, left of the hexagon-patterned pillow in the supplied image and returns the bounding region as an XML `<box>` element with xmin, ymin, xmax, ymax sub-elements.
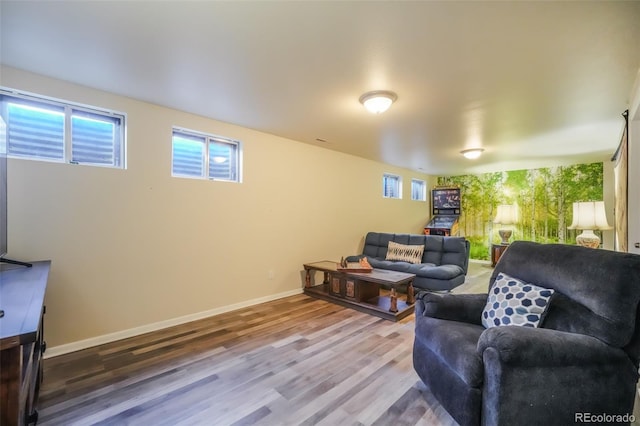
<box><xmin>415</xmin><ymin>291</ymin><xmax>487</xmax><ymax>325</ymax></box>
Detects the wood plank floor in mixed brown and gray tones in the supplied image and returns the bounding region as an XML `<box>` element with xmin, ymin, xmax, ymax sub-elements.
<box><xmin>38</xmin><ymin>266</ymin><xmax>490</xmax><ymax>426</ymax></box>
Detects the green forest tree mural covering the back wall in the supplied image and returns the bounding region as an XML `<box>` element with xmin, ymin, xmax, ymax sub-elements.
<box><xmin>438</xmin><ymin>163</ymin><xmax>603</xmax><ymax>260</ymax></box>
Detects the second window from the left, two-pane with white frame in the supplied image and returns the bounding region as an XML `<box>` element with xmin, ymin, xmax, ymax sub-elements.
<box><xmin>171</xmin><ymin>128</ymin><xmax>240</xmax><ymax>182</ymax></box>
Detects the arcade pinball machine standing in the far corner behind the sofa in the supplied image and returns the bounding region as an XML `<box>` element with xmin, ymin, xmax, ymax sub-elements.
<box><xmin>424</xmin><ymin>186</ymin><xmax>460</xmax><ymax>237</ymax></box>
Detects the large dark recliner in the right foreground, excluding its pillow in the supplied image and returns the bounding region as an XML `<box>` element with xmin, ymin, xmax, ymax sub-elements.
<box><xmin>413</xmin><ymin>241</ymin><xmax>640</xmax><ymax>426</ymax></box>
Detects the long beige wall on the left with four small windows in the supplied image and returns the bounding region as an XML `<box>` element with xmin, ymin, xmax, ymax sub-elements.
<box><xmin>0</xmin><ymin>67</ymin><xmax>434</xmax><ymax>353</ymax></box>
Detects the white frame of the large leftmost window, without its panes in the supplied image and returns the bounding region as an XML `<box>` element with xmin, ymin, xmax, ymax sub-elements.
<box><xmin>0</xmin><ymin>86</ymin><xmax>127</xmax><ymax>169</ymax></box>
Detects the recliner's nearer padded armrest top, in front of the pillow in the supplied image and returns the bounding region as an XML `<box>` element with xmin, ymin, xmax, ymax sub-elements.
<box><xmin>477</xmin><ymin>326</ymin><xmax>629</xmax><ymax>367</ymax></box>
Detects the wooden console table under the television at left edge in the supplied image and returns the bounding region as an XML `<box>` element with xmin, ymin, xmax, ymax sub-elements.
<box><xmin>0</xmin><ymin>260</ymin><xmax>51</xmax><ymax>426</ymax></box>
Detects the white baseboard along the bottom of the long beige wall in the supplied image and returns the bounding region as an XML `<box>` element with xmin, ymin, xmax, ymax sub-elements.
<box><xmin>44</xmin><ymin>288</ymin><xmax>302</xmax><ymax>359</ymax></box>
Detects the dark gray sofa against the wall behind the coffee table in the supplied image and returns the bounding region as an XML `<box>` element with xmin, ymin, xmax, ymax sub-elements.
<box><xmin>346</xmin><ymin>232</ymin><xmax>469</xmax><ymax>290</ymax></box>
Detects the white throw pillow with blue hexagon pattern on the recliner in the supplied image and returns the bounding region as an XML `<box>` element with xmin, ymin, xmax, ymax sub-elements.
<box><xmin>482</xmin><ymin>272</ymin><xmax>553</xmax><ymax>328</ymax></box>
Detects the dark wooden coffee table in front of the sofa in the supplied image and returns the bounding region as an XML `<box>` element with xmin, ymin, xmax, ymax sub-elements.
<box><xmin>303</xmin><ymin>260</ymin><xmax>415</xmax><ymax>321</ymax></box>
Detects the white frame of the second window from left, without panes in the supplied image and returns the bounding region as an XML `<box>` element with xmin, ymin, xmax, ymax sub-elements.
<box><xmin>171</xmin><ymin>126</ymin><xmax>242</xmax><ymax>183</ymax></box>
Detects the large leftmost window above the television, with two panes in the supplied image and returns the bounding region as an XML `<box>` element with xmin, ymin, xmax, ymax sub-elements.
<box><xmin>0</xmin><ymin>89</ymin><xmax>125</xmax><ymax>168</ymax></box>
